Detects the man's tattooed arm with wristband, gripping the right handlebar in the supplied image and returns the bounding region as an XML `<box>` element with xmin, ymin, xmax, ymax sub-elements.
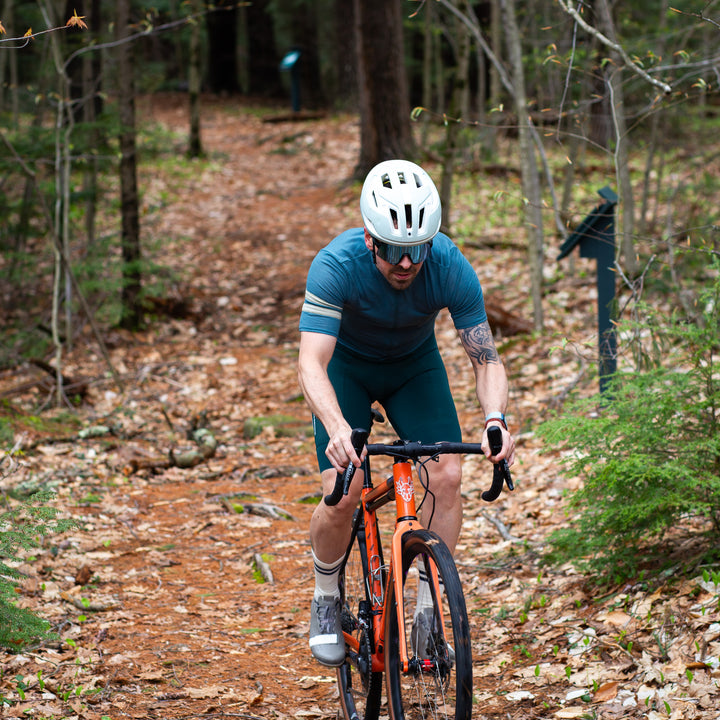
<box><xmin>458</xmin><ymin>320</ymin><xmax>515</xmax><ymax>465</ymax></box>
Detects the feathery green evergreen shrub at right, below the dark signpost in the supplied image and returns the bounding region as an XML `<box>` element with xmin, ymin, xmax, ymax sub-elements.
<box><xmin>538</xmin><ymin>263</ymin><xmax>720</xmax><ymax>582</ymax></box>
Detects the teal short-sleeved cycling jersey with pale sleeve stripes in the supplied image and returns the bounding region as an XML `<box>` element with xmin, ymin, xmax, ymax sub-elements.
<box><xmin>300</xmin><ymin>228</ymin><xmax>487</xmax><ymax>360</ymax></box>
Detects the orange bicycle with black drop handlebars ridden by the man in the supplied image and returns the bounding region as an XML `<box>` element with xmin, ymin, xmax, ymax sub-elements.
<box><xmin>325</xmin><ymin>410</ymin><xmax>513</xmax><ymax>720</ymax></box>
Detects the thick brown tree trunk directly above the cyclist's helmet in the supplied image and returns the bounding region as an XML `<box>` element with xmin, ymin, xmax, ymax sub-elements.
<box><xmin>354</xmin><ymin>0</ymin><xmax>416</xmax><ymax>179</ymax></box>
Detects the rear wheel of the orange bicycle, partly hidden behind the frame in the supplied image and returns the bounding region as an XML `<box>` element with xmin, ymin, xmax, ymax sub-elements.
<box><xmin>337</xmin><ymin>511</ymin><xmax>382</xmax><ymax>720</ymax></box>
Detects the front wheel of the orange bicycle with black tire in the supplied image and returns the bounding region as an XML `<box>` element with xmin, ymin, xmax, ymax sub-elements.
<box><xmin>385</xmin><ymin>530</ymin><xmax>472</xmax><ymax>720</ymax></box>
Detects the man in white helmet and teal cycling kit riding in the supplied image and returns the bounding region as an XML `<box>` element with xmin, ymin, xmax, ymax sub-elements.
<box><xmin>298</xmin><ymin>160</ymin><xmax>515</xmax><ymax>666</ymax></box>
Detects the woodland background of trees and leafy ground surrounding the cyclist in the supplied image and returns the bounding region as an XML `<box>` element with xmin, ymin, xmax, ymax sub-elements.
<box><xmin>0</xmin><ymin>0</ymin><xmax>720</xmax><ymax>719</ymax></box>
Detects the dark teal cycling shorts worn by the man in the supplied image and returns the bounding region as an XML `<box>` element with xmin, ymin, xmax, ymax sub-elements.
<box><xmin>313</xmin><ymin>337</ymin><xmax>462</xmax><ymax>472</ymax></box>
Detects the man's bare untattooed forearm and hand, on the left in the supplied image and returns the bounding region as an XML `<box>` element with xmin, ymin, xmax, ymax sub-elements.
<box><xmin>298</xmin><ymin>331</ymin><xmax>360</xmax><ymax>472</ymax></box>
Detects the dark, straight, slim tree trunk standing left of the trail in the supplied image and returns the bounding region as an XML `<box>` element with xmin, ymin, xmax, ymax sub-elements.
<box><xmin>115</xmin><ymin>0</ymin><xmax>142</xmax><ymax>330</ymax></box>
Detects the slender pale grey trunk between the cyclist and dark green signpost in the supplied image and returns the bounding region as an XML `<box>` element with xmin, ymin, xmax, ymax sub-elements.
<box><xmin>500</xmin><ymin>0</ymin><xmax>544</xmax><ymax>330</ymax></box>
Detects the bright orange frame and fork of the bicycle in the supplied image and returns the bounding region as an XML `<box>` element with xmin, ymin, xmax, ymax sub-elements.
<box><xmin>345</xmin><ymin>459</ymin><xmax>448</xmax><ymax>673</ymax></box>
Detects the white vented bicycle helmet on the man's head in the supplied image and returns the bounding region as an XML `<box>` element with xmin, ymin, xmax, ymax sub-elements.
<box><xmin>360</xmin><ymin>160</ymin><xmax>442</xmax><ymax>246</ymax></box>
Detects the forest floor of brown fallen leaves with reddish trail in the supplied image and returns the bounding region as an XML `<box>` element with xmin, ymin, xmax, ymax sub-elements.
<box><xmin>0</xmin><ymin>98</ymin><xmax>720</xmax><ymax>720</ymax></box>
